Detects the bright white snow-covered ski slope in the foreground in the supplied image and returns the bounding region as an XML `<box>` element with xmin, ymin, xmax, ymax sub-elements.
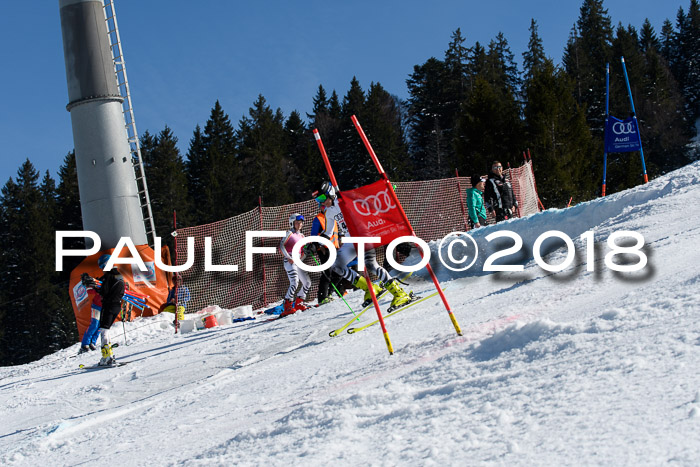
<box><xmin>0</xmin><ymin>162</ymin><xmax>700</xmax><ymax>466</ymax></box>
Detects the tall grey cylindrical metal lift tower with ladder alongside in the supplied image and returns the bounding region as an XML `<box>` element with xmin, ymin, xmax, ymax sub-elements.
<box><xmin>59</xmin><ymin>0</ymin><xmax>155</xmax><ymax>249</ymax></box>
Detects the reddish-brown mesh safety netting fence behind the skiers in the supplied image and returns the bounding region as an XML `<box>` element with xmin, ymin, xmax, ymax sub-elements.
<box><xmin>177</xmin><ymin>162</ymin><xmax>538</xmax><ymax>312</ymax></box>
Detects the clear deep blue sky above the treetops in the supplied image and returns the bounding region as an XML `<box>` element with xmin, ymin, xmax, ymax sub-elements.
<box><xmin>0</xmin><ymin>0</ymin><xmax>690</xmax><ymax>185</ymax></box>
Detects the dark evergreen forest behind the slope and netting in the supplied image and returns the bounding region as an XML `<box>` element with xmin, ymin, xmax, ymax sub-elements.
<box><xmin>0</xmin><ymin>0</ymin><xmax>700</xmax><ymax>365</ymax></box>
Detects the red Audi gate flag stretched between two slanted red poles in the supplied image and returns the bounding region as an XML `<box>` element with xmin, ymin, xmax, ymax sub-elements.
<box><xmin>338</xmin><ymin>180</ymin><xmax>412</xmax><ymax>246</ymax></box>
